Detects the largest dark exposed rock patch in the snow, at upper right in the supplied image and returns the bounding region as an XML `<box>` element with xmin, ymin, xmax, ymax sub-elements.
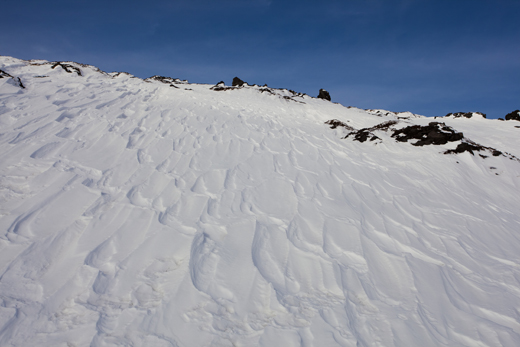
<box><xmin>392</xmin><ymin>122</ymin><xmax>464</xmax><ymax>146</ymax></box>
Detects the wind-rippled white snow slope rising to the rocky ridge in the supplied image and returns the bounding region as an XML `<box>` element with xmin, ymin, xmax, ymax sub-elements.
<box><xmin>0</xmin><ymin>57</ymin><xmax>520</xmax><ymax>346</ymax></box>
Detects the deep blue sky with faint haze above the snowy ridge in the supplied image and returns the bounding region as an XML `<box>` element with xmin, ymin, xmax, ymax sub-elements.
<box><xmin>0</xmin><ymin>0</ymin><xmax>520</xmax><ymax>118</ymax></box>
